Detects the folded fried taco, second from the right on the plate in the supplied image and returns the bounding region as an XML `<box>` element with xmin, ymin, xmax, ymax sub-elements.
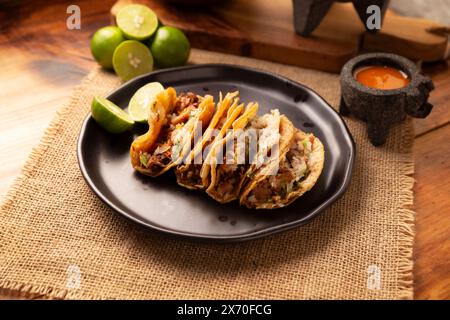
<box><xmin>202</xmin><ymin>104</ymin><xmax>294</xmax><ymax>203</ymax></box>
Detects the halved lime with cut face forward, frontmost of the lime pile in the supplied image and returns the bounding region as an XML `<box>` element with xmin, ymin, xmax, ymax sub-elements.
<box><xmin>113</xmin><ymin>40</ymin><xmax>153</xmax><ymax>81</ymax></box>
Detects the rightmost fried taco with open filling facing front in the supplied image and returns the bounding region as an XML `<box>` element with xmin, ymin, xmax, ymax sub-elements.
<box><xmin>240</xmin><ymin>129</ymin><xmax>325</xmax><ymax>209</ymax></box>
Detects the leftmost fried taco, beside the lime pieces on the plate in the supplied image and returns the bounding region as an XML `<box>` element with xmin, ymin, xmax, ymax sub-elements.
<box><xmin>130</xmin><ymin>88</ymin><xmax>214</xmax><ymax>177</ymax></box>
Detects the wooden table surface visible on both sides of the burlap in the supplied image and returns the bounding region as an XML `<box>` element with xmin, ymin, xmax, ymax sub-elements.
<box><xmin>0</xmin><ymin>0</ymin><xmax>450</xmax><ymax>299</ymax></box>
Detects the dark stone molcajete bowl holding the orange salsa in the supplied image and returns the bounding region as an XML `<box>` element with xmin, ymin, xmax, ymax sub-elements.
<box><xmin>340</xmin><ymin>53</ymin><xmax>434</xmax><ymax>146</ymax></box>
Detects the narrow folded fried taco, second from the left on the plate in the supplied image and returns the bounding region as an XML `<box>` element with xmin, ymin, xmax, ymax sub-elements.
<box><xmin>175</xmin><ymin>91</ymin><xmax>244</xmax><ymax>189</ymax></box>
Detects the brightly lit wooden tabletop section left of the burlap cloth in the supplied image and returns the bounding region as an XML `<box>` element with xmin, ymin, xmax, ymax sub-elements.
<box><xmin>0</xmin><ymin>1</ymin><xmax>113</xmax><ymax>195</ymax></box>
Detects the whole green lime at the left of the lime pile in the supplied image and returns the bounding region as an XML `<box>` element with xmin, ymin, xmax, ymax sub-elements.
<box><xmin>91</xmin><ymin>26</ymin><xmax>125</xmax><ymax>69</ymax></box>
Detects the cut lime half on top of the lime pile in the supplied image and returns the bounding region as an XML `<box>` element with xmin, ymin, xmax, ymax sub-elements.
<box><xmin>116</xmin><ymin>4</ymin><xmax>158</xmax><ymax>40</ymax></box>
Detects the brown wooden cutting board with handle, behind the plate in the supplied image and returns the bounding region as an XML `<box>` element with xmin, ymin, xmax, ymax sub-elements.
<box><xmin>111</xmin><ymin>0</ymin><xmax>448</xmax><ymax>72</ymax></box>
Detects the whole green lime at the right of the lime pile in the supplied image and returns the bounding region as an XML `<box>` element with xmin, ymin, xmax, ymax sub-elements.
<box><xmin>150</xmin><ymin>26</ymin><xmax>191</xmax><ymax>68</ymax></box>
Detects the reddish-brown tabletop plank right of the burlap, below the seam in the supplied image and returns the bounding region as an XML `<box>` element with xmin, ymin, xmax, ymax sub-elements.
<box><xmin>414</xmin><ymin>124</ymin><xmax>450</xmax><ymax>299</ymax></box>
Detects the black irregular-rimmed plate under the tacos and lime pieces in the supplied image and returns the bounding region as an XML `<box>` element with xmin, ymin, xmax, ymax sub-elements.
<box><xmin>78</xmin><ymin>64</ymin><xmax>355</xmax><ymax>241</ymax></box>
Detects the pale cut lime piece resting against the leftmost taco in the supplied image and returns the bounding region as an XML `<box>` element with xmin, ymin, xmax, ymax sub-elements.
<box><xmin>128</xmin><ymin>82</ymin><xmax>164</xmax><ymax>123</ymax></box>
